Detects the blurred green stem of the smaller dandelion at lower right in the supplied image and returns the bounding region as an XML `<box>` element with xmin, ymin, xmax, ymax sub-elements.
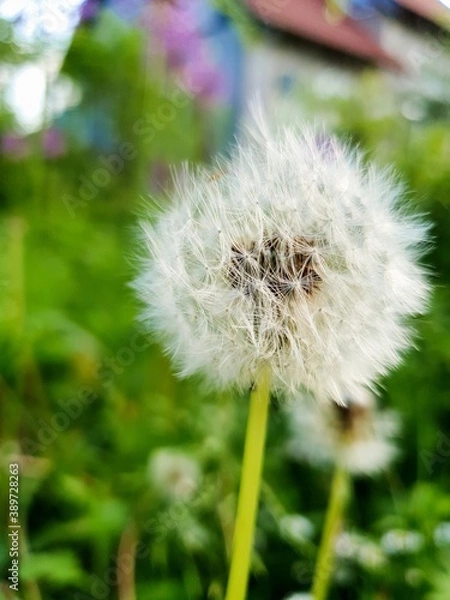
<box><xmin>312</xmin><ymin>465</ymin><xmax>349</xmax><ymax>600</ymax></box>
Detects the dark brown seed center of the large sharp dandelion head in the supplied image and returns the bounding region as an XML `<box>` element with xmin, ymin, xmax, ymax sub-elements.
<box><xmin>228</xmin><ymin>235</ymin><xmax>322</xmax><ymax>299</ymax></box>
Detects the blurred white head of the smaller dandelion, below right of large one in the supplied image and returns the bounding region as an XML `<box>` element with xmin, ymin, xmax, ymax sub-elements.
<box><xmin>285</xmin><ymin>390</ymin><xmax>400</xmax><ymax>475</ymax></box>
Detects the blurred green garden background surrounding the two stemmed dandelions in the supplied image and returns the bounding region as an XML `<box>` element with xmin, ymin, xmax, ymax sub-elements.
<box><xmin>0</xmin><ymin>1</ymin><xmax>450</xmax><ymax>600</ymax></box>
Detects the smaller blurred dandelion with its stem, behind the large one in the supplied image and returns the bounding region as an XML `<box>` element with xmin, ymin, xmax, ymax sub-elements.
<box><xmin>300</xmin><ymin>390</ymin><xmax>398</xmax><ymax>600</ymax></box>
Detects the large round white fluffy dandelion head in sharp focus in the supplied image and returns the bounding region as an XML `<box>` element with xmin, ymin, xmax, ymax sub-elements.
<box><xmin>135</xmin><ymin>121</ymin><xmax>428</xmax><ymax>402</ymax></box>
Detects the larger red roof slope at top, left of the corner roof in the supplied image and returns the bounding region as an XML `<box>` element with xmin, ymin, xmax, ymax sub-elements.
<box><xmin>246</xmin><ymin>0</ymin><xmax>402</xmax><ymax>70</ymax></box>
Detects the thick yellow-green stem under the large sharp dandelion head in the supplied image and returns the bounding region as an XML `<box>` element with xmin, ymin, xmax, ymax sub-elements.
<box><xmin>225</xmin><ymin>369</ymin><xmax>270</xmax><ymax>600</ymax></box>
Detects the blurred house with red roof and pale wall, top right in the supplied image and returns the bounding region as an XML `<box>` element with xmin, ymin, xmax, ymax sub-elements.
<box><xmin>245</xmin><ymin>0</ymin><xmax>450</xmax><ymax>122</ymax></box>
